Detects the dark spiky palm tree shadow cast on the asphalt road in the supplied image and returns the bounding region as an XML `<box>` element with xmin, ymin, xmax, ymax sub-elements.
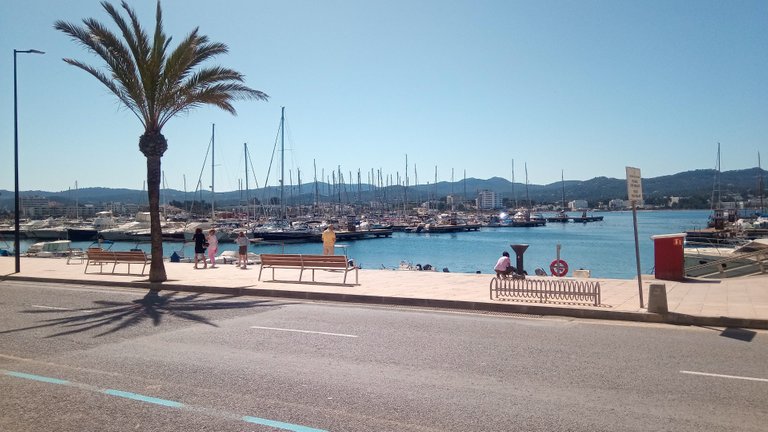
<box><xmin>0</xmin><ymin>290</ymin><xmax>282</xmax><ymax>337</ymax></box>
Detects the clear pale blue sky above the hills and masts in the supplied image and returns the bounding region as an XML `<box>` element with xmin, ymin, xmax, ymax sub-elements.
<box><xmin>0</xmin><ymin>0</ymin><xmax>768</xmax><ymax>191</ymax></box>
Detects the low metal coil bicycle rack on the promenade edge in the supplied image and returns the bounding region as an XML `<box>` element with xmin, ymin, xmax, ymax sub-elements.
<box><xmin>489</xmin><ymin>278</ymin><xmax>600</xmax><ymax>306</ymax></box>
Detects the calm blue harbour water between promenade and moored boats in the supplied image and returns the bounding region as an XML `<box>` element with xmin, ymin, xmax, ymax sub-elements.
<box><xmin>15</xmin><ymin>210</ymin><xmax>710</xmax><ymax>279</ymax></box>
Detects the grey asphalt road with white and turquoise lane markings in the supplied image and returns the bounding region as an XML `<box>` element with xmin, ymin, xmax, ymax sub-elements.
<box><xmin>0</xmin><ymin>281</ymin><xmax>768</xmax><ymax>432</ymax></box>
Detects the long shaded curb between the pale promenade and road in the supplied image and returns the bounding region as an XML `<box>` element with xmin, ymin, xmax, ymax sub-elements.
<box><xmin>7</xmin><ymin>275</ymin><xmax>768</xmax><ymax>330</ymax></box>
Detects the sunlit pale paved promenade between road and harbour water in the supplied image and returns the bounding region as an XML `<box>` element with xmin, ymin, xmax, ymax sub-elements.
<box><xmin>0</xmin><ymin>257</ymin><xmax>768</xmax><ymax>329</ymax></box>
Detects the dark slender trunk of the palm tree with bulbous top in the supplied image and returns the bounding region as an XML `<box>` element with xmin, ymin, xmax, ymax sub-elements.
<box><xmin>139</xmin><ymin>132</ymin><xmax>168</xmax><ymax>282</ymax></box>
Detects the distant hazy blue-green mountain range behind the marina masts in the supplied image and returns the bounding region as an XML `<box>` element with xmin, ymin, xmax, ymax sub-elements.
<box><xmin>0</xmin><ymin>168</ymin><xmax>766</xmax><ymax>210</ymax></box>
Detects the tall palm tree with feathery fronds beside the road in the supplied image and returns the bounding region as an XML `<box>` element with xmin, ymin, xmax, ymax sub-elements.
<box><xmin>54</xmin><ymin>0</ymin><xmax>268</xmax><ymax>282</ymax></box>
